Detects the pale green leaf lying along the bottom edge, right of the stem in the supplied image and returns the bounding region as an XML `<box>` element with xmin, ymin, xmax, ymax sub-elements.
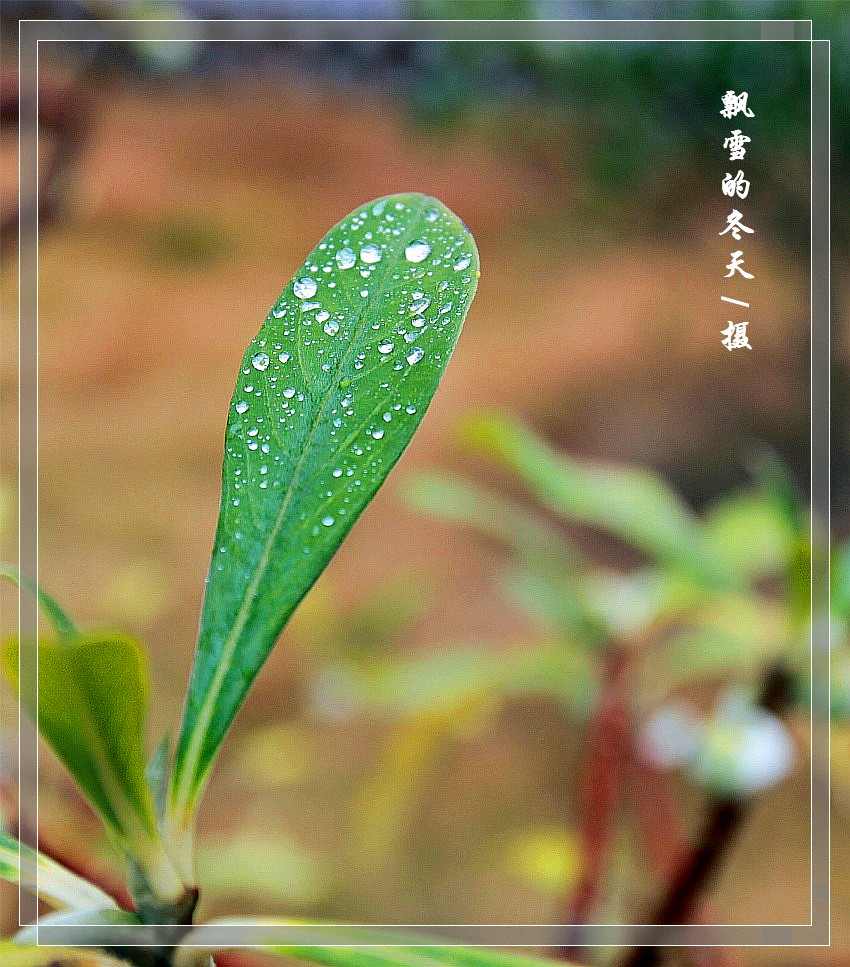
<box><xmin>175</xmin><ymin>917</ymin><xmax>569</xmax><ymax>967</ymax></box>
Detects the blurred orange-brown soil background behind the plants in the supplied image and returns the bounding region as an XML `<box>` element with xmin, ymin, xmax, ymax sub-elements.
<box><xmin>0</xmin><ymin>3</ymin><xmax>850</xmax><ymax>964</ymax></box>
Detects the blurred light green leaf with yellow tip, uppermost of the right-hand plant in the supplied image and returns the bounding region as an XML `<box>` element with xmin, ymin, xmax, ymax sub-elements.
<box><xmin>461</xmin><ymin>414</ymin><xmax>736</xmax><ymax>587</ymax></box>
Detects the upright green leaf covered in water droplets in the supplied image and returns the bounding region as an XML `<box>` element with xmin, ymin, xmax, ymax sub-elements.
<box><xmin>170</xmin><ymin>194</ymin><xmax>478</xmax><ymax>829</ymax></box>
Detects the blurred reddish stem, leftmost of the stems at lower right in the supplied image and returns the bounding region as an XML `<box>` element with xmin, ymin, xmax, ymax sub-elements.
<box><xmin>557</xmin><ymin>645</ymin><xmax>631</xmax><ymax>961</ymax></box>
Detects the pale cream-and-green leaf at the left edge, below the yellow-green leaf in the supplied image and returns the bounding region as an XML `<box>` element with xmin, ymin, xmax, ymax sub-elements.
<box><xmin>0</xmin><ymin>832</ymin><xmax>118</xmax><ymax>910</ymax></box>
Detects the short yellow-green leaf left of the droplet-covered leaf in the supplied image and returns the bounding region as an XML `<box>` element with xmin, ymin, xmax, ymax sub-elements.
<box><xmin>3</xmin><ymin>635</ymin><xmax>182</xmax><ymax>896</ymax></box>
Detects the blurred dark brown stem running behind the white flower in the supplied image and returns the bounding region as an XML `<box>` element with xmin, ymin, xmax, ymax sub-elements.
<box><xmin>623</xmin><ymin>665</ymin><xmax>792</xmax><ymax>967</ymax></box>
